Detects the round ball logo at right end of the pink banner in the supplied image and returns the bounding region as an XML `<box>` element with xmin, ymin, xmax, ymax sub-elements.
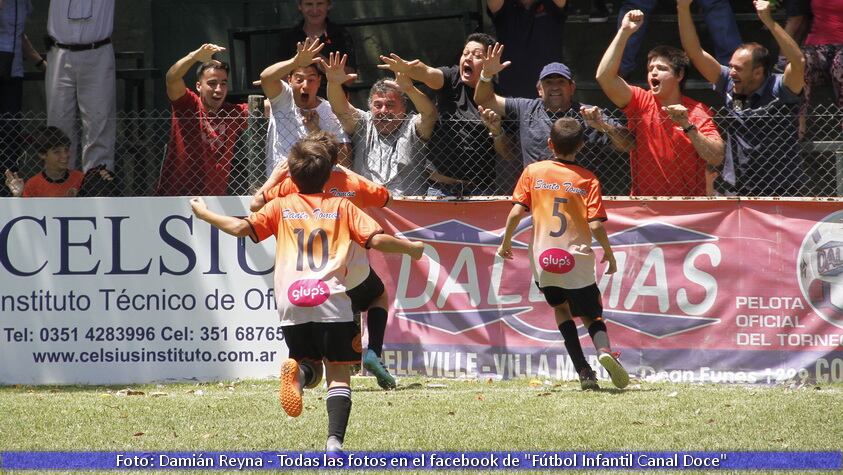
<box><xmin>796</xmin><ymin>211</ymin><xmax>843</xmax><ymax>328</ymax></box>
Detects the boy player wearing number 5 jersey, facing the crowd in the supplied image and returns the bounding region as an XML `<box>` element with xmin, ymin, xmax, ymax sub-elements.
<box><xmin>498</xmin><ymin>118</ymin><xmax>629</xmax><ymax>389</ymax></box>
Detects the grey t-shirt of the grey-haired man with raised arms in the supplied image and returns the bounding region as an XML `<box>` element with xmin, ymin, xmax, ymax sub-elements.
<box><xmin>351</xmin><ymin>109</ymin><xmax>430</xmax><ymax>196</ymax></box>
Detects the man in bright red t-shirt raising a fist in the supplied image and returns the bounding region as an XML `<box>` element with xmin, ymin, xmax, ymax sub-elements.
<box><xmin>597</xmin><ymin>10</ymin><xmax>724</xmax><ymax>196</ymax></box>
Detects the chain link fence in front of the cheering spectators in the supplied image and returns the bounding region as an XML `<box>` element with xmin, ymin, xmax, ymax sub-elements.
<box><xmin>0</xmin><ymin>104</ymin><xmax>843</xmax><ymax>199</ymax></box>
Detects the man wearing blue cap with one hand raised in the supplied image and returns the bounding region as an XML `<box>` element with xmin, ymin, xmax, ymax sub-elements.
<box><xmin>474</xmin><ymin>44</ymin><xmax>633</xmax><ymax>176</ymax></box>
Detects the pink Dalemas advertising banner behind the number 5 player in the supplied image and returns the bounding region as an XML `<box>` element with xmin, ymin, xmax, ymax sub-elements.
<box><xmin>370</xmin><ymin>200</ymin><xmax>843</xmax><ymax>382</ymax></box>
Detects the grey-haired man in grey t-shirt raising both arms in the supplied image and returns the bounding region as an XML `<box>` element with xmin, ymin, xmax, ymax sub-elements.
<box><xmin>323</xmin><ymin>53</ymin><xmax>439</xmax><ymax>196</ymax></box>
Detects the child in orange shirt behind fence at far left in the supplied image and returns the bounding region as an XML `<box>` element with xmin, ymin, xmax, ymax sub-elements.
<box><xmin>6</xmin><ymin>127</ymin><xmax>113</xmax><ymax>198</ymax></box>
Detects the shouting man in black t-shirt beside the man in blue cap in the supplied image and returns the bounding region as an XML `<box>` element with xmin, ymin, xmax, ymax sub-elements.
<box><xmin>378</xmin><ymin>33</ymin><xmax>509</xmax><ymax>196</ymax></box>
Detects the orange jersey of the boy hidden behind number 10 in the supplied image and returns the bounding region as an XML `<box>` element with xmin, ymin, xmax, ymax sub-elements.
<box><xmin>263</xmin><ymin>166</ymin><xmax>389</xmax><ymax>209</ymax></box>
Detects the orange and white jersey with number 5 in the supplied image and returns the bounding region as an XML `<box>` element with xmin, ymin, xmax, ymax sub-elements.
<box><xmin>512</xmin><ymin>160</ymin><xmax>606</xmax><ymax>289</ymax></box>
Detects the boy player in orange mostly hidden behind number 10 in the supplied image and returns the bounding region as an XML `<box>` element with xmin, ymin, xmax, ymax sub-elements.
<box><xmin>250</xmin><ymin>131</ymin><xmax>395</xmax><ymax>389</ymax></box>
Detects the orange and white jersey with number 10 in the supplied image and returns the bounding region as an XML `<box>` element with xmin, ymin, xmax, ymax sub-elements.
<box><xmin>246</xmin><ymin>193</ymin><xmax>383</xmax><ymax>326</ymax></box>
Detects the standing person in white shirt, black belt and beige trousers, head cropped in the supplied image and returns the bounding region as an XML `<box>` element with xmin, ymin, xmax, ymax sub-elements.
<box><xmin>44</xmin><ymin>0</ymin><xmax>117</xmax><ymax>171</ymax></box>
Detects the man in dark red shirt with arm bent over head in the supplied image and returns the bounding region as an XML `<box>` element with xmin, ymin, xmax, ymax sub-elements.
<box><xmin>157</xmin><ymin>44</ymin><xmax>248</xmax><ymax>196</ymax></box>
